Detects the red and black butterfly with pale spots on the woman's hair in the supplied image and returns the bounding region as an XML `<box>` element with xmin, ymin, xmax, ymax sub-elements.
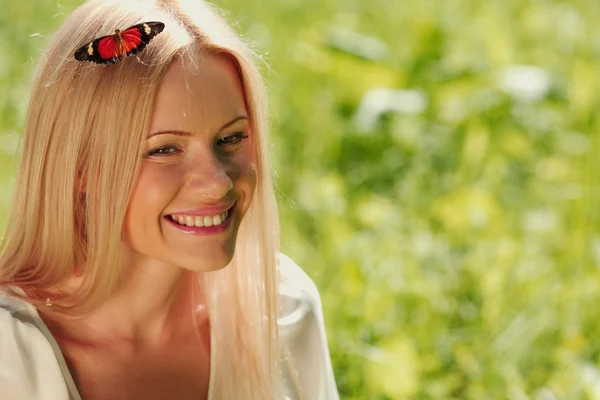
<box><xmin>75</xmin><ymin>21</ymin><xmax>165</xmax><ymax>65</ymax></box>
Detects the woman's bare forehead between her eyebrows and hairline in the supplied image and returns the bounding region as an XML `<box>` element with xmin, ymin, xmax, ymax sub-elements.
<box><xmin>150</xmin><ymin>55</ymin><xmax>247</xmax><ymax>132</ymax></box>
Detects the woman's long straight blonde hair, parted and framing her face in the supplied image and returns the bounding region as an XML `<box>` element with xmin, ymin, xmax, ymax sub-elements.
<box><xmin>0</xmin><ymin>0</ymin><xmax>283</xmax><ymax>399</ymax></box>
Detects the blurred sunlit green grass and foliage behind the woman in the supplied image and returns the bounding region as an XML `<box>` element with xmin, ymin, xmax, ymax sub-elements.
<box><xmin>0</xmin><ymin>0</ymin><xmax>600</xmax><ymax>400</ymax></box>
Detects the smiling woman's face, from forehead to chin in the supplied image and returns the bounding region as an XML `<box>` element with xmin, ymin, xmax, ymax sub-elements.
<box><xmin>124</xmin><ymin>56</ymin><xmax>256</xmax><ymax>272</ymax></box>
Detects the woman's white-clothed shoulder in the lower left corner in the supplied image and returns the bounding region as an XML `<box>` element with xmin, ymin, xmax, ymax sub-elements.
<box><xmin>0</xmin><ymin>294</ymin><xmax>68</xmax><ymax>400</ymax></box>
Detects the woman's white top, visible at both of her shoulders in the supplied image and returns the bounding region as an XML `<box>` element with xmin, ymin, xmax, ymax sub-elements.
<box><xmin>0</xmin><ymin>254</ymin><xmax>339</xmax><ymax>400</ymax></box>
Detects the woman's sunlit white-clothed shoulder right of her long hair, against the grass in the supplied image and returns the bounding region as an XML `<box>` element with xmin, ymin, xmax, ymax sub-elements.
<box><xmin>278</xmin><ymin>254</ymin><xmax>339</xmax><ymax>400</ymax></box>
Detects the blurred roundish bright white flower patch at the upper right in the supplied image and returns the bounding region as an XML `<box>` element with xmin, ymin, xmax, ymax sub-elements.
<box><xmin>498</xmin><ymin>65</ymin><xmax>550</xmax><ymax>102</ymax></box>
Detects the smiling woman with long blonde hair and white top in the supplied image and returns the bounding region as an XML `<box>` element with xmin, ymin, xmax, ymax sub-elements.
<box><xmin>0</xmin><ymin>0</ymin><xmax>338</xmax><ymax>400</ymax></box>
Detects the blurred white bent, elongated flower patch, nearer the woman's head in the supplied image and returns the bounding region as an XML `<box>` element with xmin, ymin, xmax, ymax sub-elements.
<box><xmin>354</xmin><ymin>87</ymin><xmax>428</xmax><ymax>132</ymax></box>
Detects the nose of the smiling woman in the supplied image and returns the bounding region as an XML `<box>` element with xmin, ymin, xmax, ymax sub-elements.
<box><xmin>186</xmin><ymin>152</ymin><xmax>233</xmax><ymax>200</ymax></box>
